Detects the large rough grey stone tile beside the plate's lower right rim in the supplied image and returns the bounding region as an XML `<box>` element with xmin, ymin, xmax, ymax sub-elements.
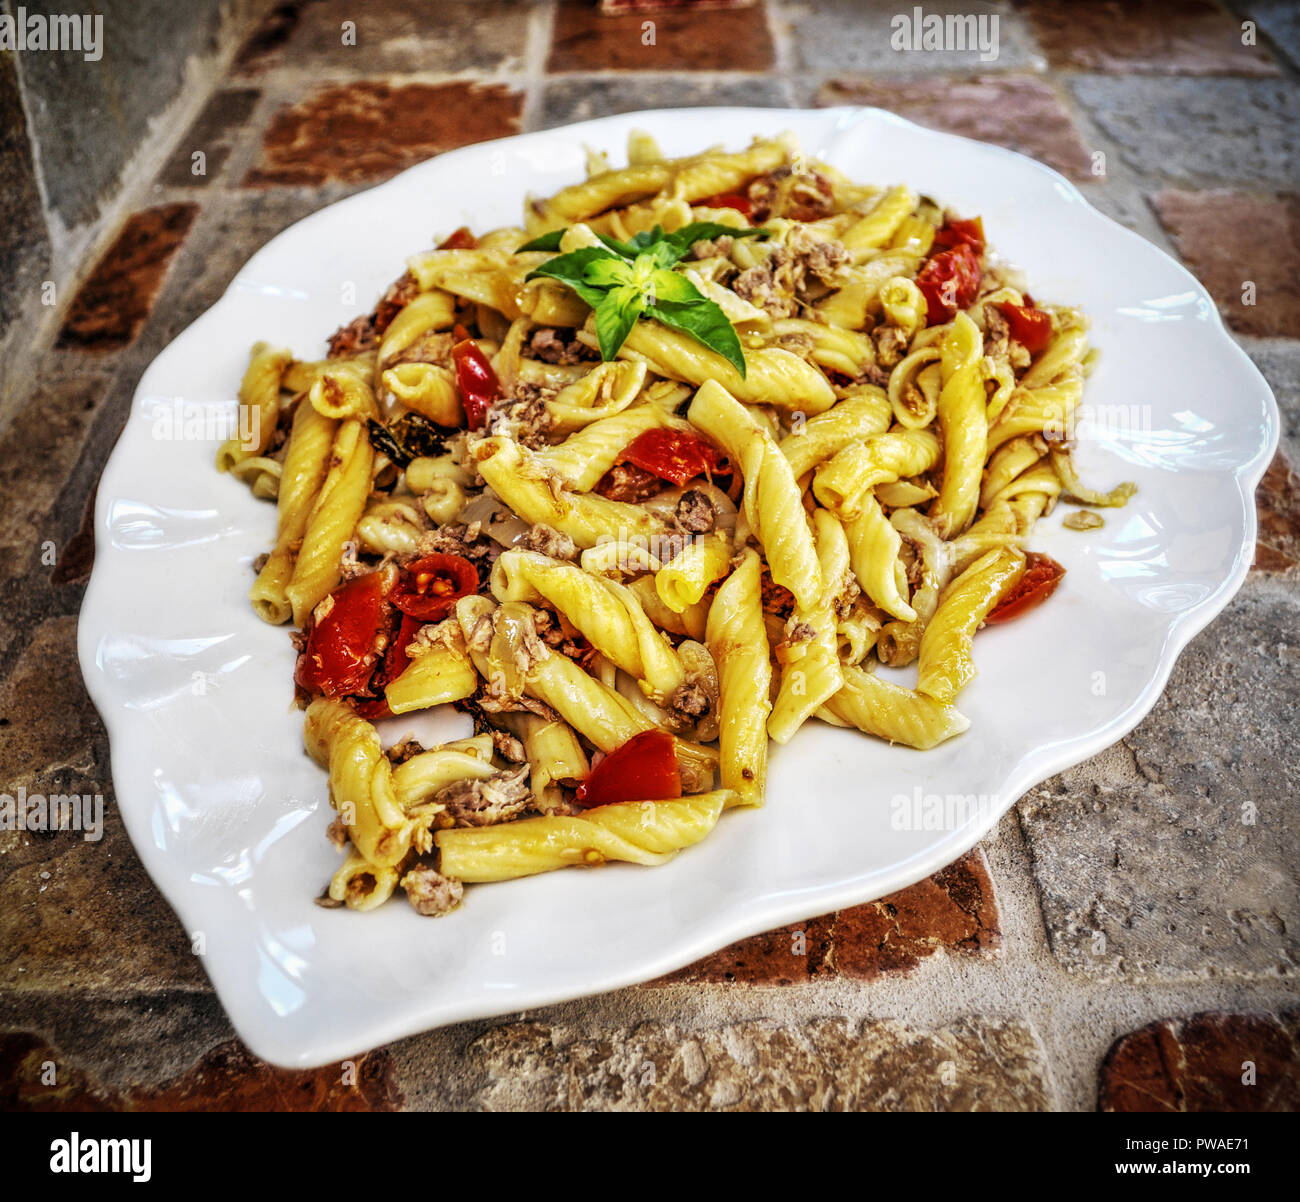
<box><xmin>1019</xmin><ymin>577</ymin><xmax>1300</xmax><ymax>981</ymax></box>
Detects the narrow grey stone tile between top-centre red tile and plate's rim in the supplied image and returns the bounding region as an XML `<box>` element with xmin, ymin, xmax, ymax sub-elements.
<box><xmin>538</xmin><ymin>75</ymin><xmax>790</xmax><ymax>129</ymax></box>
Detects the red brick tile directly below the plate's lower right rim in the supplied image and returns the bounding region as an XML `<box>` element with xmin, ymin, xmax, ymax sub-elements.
<box><xmin>654</xmin><ymin>849</ymin><xmax>1001</xmax><ymax>985</ymax></box>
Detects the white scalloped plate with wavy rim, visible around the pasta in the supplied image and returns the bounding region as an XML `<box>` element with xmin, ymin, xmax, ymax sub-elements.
<box><xmin>79</xmin><ymin>109</ymin><xmax>1278</xmax><ymax>1066</ymax></box>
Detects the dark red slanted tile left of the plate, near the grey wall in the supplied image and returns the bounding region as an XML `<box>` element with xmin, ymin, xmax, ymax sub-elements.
<box><xmin>59</xmin><ymin>204</ymin><xmax>199</xmax><ymax>351</ymax></box>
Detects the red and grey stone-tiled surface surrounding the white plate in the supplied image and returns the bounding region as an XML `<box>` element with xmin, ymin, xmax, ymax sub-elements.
<box><xmin>0</xmin><ymin>0</ymin><xmax>1300</xmax><ymax>1111</ymax></box>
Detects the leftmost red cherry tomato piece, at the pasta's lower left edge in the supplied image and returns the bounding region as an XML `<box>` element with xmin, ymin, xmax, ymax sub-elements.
<box><xmin>294</xmin><ymin>570</ymin><xmax>394</xmax><ymax>697</ymax></box>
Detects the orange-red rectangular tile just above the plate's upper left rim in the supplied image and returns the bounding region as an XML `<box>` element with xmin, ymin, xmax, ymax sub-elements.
<box><xmin>244</xmin><ymin>81</ymin><xmax>523</xmax><ymax>187</ymax></box>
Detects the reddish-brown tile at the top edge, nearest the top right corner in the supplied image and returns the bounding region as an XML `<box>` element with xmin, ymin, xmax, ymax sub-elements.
<box><xmin>1018</xmin><ymin>0</ymin><xmax>1278</xmax><ymax>75</ymax></box>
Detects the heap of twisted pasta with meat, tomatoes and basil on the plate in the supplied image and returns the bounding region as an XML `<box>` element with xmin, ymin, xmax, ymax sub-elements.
<box><xmin>216</xmin><ymin>134</ymin><xmax>1134</xmax><ymax>915</ymax></box>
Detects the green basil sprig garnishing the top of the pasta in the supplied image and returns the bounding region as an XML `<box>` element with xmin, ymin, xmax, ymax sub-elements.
<box><xmin>519</xmin><ymin>221</ymin><xmax>770</xmax><ymax>376</ymax></box>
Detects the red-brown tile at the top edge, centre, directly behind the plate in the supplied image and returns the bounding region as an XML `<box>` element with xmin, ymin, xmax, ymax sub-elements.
<box><xmin>547</xmin><ymin>0</ymin><xmax>772</xmax><ymax>71</ymax></box>
